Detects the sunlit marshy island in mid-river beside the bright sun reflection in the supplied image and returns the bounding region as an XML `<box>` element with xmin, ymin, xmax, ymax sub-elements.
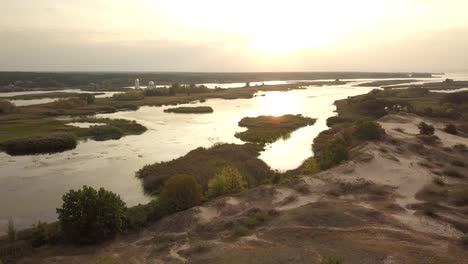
<box><xmin>235</xmin><ymin>115</ymin><xmax>316</xmax><ymax>145</ymax></box>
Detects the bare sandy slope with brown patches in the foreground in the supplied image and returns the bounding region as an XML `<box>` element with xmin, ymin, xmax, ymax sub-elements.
<box><xmin>21</xmin><ymin>116</ymin><xmax>468</xmax><ymax>264</ymax></box>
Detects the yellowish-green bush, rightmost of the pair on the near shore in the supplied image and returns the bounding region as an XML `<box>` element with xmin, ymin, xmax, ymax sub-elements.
<box><xmin>208</xmin><ymin>166</ymin><xmax>247</xmax><ymax>197</ymax></box>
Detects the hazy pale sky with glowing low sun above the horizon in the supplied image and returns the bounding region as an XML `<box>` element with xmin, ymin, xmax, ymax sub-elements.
<box><xmin>0</xmin><ymin>0</ymin><xmax>468</xmax><ymax>72</ymax></box>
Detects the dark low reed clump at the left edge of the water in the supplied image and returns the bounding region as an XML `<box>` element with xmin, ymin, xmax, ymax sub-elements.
<box><xmin>1</xmin><ymin>134</ymin><xmax>78</xmax><ymax>155</ymax></box>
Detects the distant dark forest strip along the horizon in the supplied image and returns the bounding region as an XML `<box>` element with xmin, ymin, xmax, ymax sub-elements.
<box><xmin>0</xmin><ymin>72</ymin><xmax>432</xmax><ymax>92</ymax></box>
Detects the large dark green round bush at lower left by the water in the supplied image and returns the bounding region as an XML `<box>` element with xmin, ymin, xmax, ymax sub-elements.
<box><xmin>57</xmin><ymin>186</ymin><xmax>126</xmax><ymax>244</ymax></box>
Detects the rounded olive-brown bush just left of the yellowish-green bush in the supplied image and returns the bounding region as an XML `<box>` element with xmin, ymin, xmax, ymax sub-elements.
<box><xmin>159</xmin><ymin>175</ymin><xmax>203</xmax><ymax>213</ymax></box>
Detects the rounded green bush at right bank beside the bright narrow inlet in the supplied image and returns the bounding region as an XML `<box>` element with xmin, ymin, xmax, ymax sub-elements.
<box><xmin>317</xmin><ymin>136</ymin><xmax>349</xmax><ymax>170</ymax></box>
